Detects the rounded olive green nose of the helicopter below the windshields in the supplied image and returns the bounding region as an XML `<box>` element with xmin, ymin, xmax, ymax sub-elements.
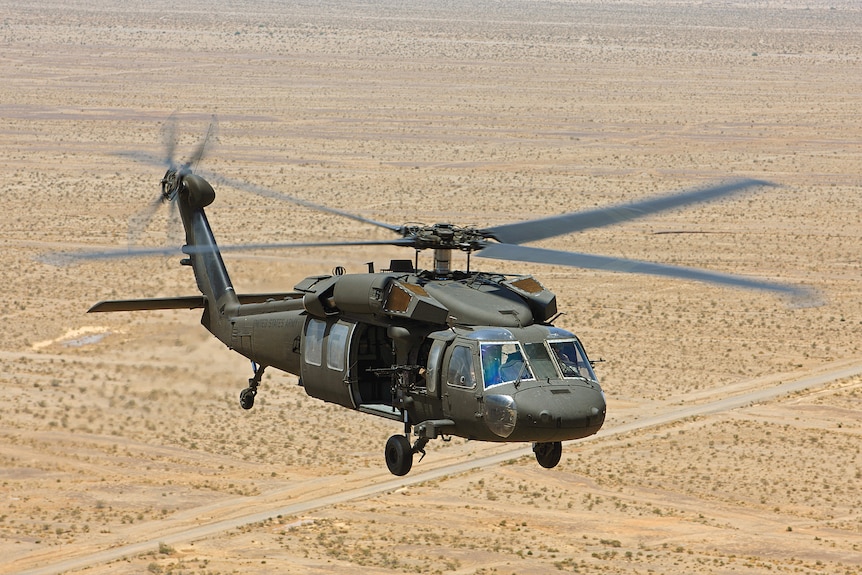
<box><xmin>513</xmin><ymin>381</ymin><xmax>607</xmax><ymax>441</ymax></box>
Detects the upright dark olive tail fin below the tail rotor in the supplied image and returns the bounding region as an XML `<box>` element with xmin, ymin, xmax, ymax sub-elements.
<box><xmin>176</xmin><ymin>174</ymin><xmax>239</xmax><ymax>326</ymax></box>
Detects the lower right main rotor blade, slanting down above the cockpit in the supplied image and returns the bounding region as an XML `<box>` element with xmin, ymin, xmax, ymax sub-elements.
<box><xmin>476</xmin><ymin>244</ymin><xmax>818</xmax><ymax>305</ymax></box>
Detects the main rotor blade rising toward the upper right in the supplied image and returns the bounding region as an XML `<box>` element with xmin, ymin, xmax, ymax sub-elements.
<box><xmin>485</xmin><ymin>179</ymin><xmax>775</xmax><ymax>244</ymax></box>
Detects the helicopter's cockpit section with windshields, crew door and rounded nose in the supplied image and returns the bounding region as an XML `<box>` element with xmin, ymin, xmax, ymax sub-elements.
<box><xmin>442</xmin><ymin>324</ymin><xmax>606</xmax><ymax>442</ymax></box>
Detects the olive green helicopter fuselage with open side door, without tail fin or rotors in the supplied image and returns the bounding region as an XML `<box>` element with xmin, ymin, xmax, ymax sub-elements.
<box><xmin>203</xmin><ymin>273</ymin><xmax>605</xmax><ymax>442</ymax></box>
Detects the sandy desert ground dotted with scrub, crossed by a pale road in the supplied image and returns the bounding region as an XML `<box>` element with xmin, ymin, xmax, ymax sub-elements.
<box><xmin>0</xmin><ymin>0</ymin><xmax>862</xmax><ymax>575</ymax></box>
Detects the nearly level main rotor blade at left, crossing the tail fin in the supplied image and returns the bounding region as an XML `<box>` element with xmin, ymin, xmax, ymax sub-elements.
<box><xmin>38</xmin><ymin>238</ymin><xmax>414</xmax><ymax>266</ymax></box>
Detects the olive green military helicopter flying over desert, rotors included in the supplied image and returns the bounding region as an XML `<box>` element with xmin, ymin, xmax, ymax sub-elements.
<box><xmin>71</xmin><ymin>122</ymin><xmax>809</xmax><ymax>476</ymax></box>
